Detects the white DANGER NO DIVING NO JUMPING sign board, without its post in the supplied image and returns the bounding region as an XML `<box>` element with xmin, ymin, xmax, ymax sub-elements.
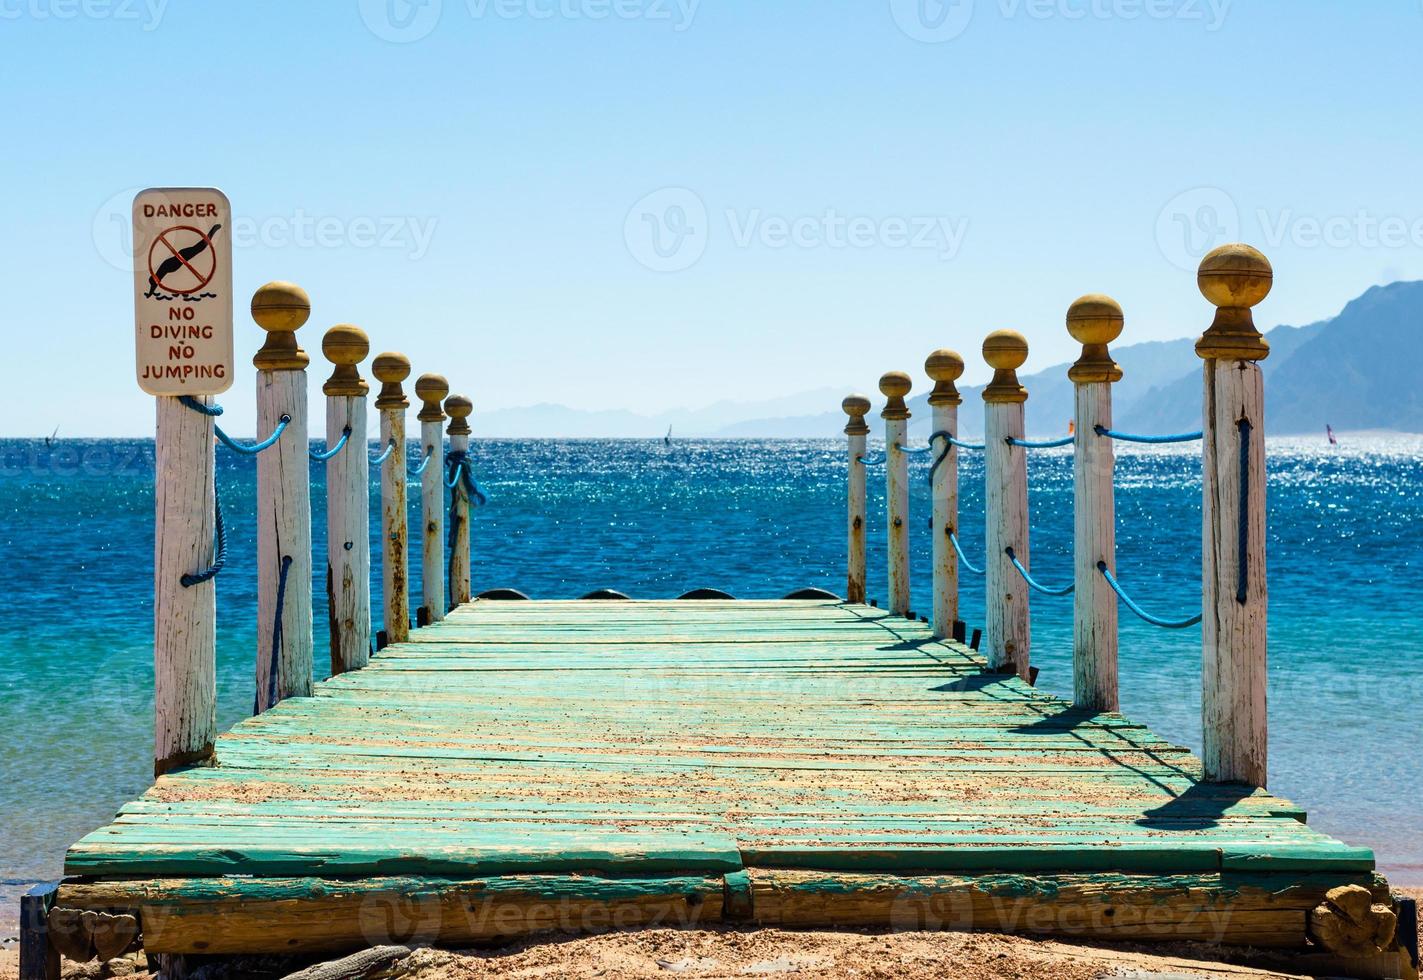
<box><xmin>134</xmin><ymin>188</ymin><xmax>232</xmax><ymax>395</ymax></box>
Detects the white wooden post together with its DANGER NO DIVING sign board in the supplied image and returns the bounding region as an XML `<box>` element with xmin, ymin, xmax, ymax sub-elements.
<box><xmin>134</xmin><ymin>188</ymin><xmax>232</xmax><ymax>775</ymax></box>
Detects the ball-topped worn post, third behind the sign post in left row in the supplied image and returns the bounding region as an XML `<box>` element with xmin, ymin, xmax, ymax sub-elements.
<box><xmin>371</xmin><ymin>353</ymin><xmax>410</xmax><ymax>643</ymax></box>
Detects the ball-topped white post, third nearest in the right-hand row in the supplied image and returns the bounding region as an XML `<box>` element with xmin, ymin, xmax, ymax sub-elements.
<box><xmin>983</xmin><ymin>330</ymin><xmax>1032</xmax><ymax>678</ymax></box>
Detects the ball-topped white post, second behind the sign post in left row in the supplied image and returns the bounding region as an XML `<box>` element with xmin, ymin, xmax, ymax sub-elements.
<box><xmin>322</xmin><ymin>324</ymin><xmax>370</xmax><ymax>674</ymax></box>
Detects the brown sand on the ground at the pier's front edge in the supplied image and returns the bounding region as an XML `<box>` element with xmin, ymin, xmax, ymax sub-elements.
<box><xmin>0</xmin><ymin>930</ymin><xmax>1326</xmax><ymax>980</ymax></box>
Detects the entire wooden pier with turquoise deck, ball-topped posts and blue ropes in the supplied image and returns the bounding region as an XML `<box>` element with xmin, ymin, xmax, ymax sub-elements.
<box><xmin>21</xmin><ymin>216</ymin><xmax>1417</xmax><ymax>980</ymax></box>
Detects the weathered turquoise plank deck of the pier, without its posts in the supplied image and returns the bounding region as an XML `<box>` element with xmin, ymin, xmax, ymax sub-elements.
<box><xmin>55</xmin><ymin>600</ymin><xmax>1387</xmax><ymax>953</ymax></box>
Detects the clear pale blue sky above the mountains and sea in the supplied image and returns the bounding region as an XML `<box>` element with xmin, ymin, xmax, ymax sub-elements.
<box><xmin>0</xmin><ymin>0</ymin><xmax>1423</xmax><ymax>435</ymax></box>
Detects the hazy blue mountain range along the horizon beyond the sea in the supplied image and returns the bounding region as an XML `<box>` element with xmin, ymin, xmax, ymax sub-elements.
<box><xmin>478</xmin><ymin>282</ymin><xmax>1423</xmax><ymax>440</ymax></box>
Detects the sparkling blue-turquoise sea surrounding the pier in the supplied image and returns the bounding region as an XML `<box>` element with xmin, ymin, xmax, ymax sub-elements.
<box><xmin>0</xmin><ymin>435</ymin><xmax>1423</xmax><ymax>937</ymax></box>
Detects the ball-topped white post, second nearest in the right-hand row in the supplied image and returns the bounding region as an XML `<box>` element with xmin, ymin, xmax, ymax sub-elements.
<box><xmin>1067</xmin><ymin>296</ymin><xmax>1123</xmax><ymax>711</ymax></box>
